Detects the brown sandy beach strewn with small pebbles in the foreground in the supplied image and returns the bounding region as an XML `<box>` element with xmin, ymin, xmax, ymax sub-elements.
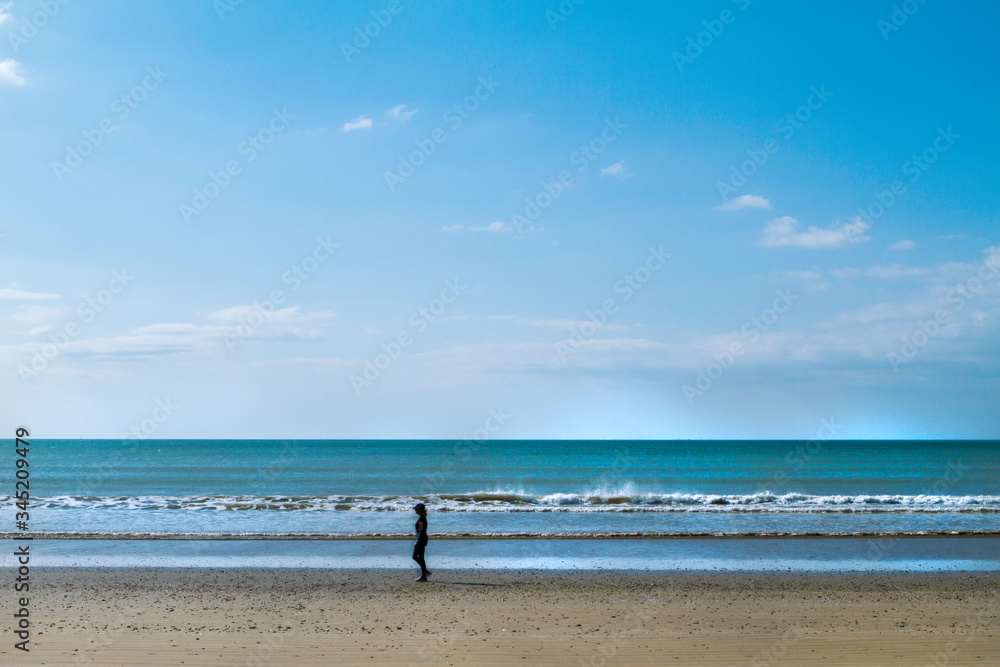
<box><xmin>0</xmin><ymin>568</ymin><xmax>1000</xmax><ymax>666</ymax></box>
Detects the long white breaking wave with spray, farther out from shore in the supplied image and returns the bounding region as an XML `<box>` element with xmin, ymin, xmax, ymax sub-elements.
<box><xmin>0</xmin><ymin>490</ymin><xmax>1000</xmax><ymax>514</ymax></box>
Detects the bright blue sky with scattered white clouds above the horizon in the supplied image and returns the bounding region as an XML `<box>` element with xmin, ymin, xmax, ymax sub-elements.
<box><xmin>0</xmin><ymin>0</ymin><xmax>1000</xmax><ymax>439</ymax></box>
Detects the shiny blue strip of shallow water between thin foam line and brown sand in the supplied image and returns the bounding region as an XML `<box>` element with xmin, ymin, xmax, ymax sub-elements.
<box><xmin>9</xmin><ymin>534</ymin><xmax>1000</xmax><ymax>572</ymax></box>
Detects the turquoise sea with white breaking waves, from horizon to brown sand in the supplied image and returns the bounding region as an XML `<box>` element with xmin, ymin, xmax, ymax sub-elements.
<box><xmin>0</xmin><ymin>439</ymin><xmax>1000</xmax><ymax>569</ymax></box>
